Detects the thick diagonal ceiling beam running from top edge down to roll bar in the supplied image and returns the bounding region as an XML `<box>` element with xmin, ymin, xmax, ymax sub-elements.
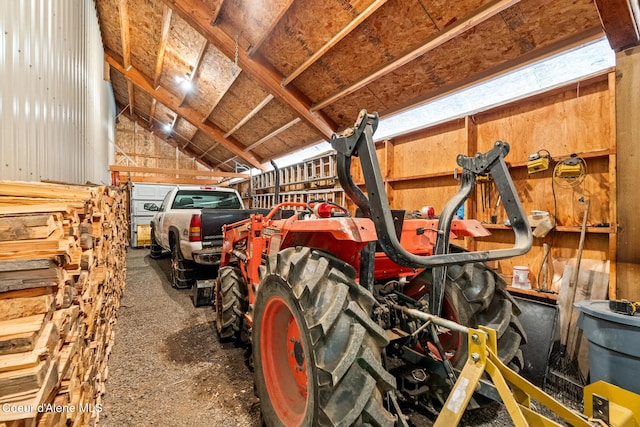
<box><xmin>163</xmin><ymin>0</ymin><xmax>337</xmax><ymax>139</ymax></box>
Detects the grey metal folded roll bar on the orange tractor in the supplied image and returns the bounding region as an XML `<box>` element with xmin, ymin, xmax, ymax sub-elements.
<box><xmin>331</xmin><ymin>110</ymin><xmax>533</xmax><ymax>314</ymax></box>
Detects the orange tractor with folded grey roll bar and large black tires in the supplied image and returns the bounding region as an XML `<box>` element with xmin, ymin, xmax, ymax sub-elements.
<box><xmin>215</xmin><ymin>111</ymin><xmax>532</xmax><ymax>426</ymax></box>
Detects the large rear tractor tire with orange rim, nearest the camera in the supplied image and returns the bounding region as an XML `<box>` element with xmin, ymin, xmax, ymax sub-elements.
<box><xmin>252</xmin><ymin>247</ymin><xmax>396</xmax><ymax>427</ymax></box>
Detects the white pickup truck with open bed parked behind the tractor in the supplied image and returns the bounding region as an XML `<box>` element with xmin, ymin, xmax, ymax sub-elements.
<box><xmin>144</xmin><ymin>186</ymin><xmax>251</xmax><ymax>288</ymax></box>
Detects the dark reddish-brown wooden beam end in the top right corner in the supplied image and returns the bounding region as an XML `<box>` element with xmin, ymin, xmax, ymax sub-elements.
<box><xmin>595</xmin><ymin>0</ymin><xmax>640</xmax><ymax>52</ymax></box>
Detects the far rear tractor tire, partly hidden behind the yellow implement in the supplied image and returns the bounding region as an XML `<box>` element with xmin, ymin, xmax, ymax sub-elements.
<box><xmin>405</xmin><ymin>262</ymin><xmax>527</xmax><ymax>372</ymax></box>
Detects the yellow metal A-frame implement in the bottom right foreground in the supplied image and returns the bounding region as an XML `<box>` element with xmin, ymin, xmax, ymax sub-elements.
<box><xmin>434</xmin><ymin>326</ymin><xmax>640</xmax><ymax>427</ymax></box>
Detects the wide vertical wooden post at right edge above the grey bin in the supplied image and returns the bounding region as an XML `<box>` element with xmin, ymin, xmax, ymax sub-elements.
<box><xmin>616</xmin><ymin>47</ymin><xmax>640</xmax><ymax>301</ymax></box>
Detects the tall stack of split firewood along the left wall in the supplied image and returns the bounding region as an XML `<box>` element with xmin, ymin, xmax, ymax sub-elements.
<box><xmin>0</xmin><ymin>181</ymin><xmax>128</xmax><ymax>427</ymax></box>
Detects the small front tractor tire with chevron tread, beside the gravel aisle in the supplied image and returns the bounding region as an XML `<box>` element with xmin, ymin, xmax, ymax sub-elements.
<box><xmin>215</xmin><ymin>267</ymin><xmax>247</xmax><ymax>341</ymax></box>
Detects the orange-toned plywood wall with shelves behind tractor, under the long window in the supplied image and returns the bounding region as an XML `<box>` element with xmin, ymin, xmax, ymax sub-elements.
<box><xmin>353</xmin><ymin>73</ymin><xmax>616</xmax><ymax>297</ymax></box>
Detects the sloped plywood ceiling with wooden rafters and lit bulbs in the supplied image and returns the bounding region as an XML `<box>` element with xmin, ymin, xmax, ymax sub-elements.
<box><xmin>96</xmin><ymin>0</ymin><xmax>637</xmax><ymax>171</ymax></box>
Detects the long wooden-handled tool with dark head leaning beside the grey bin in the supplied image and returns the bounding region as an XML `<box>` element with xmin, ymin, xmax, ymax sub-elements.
<box><xmin>543</xmin><ymin>200</ymin><xmax>590</xmax><ymax>402</ymax></box>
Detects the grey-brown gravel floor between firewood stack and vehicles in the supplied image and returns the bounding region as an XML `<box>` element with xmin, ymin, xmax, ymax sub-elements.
<box><xmin>100</xmin><ymin>249</ymin><xmax>564</xmax><ymax>427</ymax></box>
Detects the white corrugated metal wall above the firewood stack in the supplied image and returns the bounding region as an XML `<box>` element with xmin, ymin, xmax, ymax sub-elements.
<box><xmin>0</xmin><ymin>0</ymin><xmax>115</xmax><ymax>183</ymax></box>
